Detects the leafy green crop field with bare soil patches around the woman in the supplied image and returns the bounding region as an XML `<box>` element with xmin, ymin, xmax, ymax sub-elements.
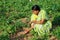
<box><xmin>0</xmin><ymin>0</ymin><xmax>60</xmax><ymax>40</ymax></box>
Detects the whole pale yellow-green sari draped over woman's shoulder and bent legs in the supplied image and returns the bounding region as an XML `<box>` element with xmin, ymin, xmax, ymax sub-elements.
<box><xmin>34</xmin><ymin>10</ymin><xmax>52</xmax><ymax>37</ymax></box>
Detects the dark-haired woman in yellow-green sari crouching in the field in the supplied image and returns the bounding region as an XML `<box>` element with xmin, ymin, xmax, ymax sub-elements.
<box><xmin>28</xmin><ymin>5</ymin><xmax>52</xmax><ymax>37</ymax></box>
